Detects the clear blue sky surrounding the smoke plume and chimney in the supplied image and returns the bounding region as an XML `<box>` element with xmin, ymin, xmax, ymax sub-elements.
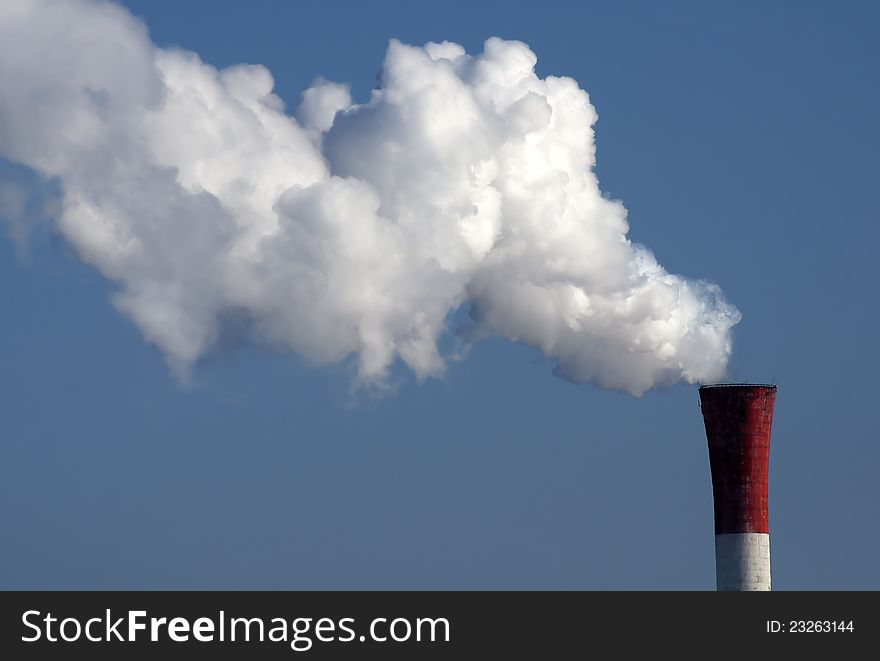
<box><xmin>0</xmin><ymin>0</ymin><xmax>880</xmax><ymax>590</ymax></box>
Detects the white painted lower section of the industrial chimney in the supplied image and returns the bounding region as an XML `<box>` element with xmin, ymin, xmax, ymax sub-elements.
<box><xmin>715</xmin><ymin>532</ymin><xmax>770</xmax><ymax>591</ymax></box>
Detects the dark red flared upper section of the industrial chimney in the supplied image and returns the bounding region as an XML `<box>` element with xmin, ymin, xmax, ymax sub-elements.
<box><xmin>700</xmin><ymin>384</ymin><xmax>776</xmax><ymax>535</ymax></box>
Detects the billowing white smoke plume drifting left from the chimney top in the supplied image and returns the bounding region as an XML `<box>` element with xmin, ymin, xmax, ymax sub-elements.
<box><xmin>0</xmin><ymin>0</ymin><xmax>739</xmax><ymax>394</ymax></box>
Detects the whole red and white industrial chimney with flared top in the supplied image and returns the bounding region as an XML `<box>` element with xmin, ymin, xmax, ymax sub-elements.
<box><xmin>700</xmin><ymin>384</ymin><xmax>776</xmax><ymax>590</ymax></box>
